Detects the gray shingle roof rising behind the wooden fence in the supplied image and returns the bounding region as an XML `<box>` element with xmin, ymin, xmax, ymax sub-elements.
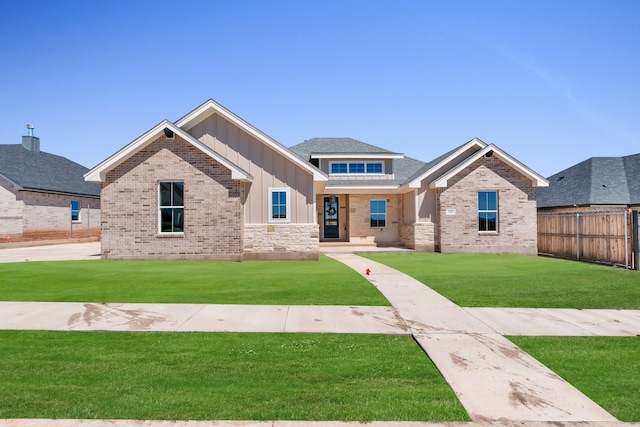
<box><xmin>537</xmin><ymin>154</ymin><xmax>640</xmax><ymax>208</ymax></box>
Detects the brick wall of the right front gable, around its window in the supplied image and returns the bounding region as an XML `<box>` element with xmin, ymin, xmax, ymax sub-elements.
<box><xmin>438</xmin><ymin>156</ymin><xmax>538</xmax><ymax>255</ymax></box>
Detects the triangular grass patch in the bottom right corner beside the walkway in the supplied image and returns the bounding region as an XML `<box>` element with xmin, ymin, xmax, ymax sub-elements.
<box><xmin>509</xmin><ymin>337</ymin><xmax>640</xmax><ymax>422</ymax></box>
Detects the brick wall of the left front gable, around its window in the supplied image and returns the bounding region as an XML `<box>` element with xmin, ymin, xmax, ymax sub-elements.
<box><xmin>102</xmin><ymin>136</ymin><xmax>244</xmax><ymax>261</ymax></box>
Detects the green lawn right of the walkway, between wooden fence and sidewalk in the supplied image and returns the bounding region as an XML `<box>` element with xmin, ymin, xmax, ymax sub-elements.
<box><xmin>364</xmin><ymin>253</ymin><xmax>640</xmax><ymax>310</ymax></box>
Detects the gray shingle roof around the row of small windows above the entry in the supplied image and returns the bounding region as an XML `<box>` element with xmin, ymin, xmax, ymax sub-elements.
<box><xmin>290</xmin><ymin>138</ymin><xmax>425</xmax><ymax>186</ymax></box>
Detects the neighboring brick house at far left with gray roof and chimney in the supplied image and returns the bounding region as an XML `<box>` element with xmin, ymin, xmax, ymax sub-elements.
<box><xmin>0</xmin><ymin>127</ymin><xmax>100</xmax><ymax>241</ymax></box>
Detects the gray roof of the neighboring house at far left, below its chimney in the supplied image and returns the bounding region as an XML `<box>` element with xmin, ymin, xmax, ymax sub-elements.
<box><xmin>0</xmin><ymin>144</ymin><xmax>100</xmax><ymax>197</ymax></box>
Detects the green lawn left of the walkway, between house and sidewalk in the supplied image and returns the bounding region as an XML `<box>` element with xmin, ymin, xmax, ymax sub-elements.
<box><xmin>0</xmin><ymin>256</ymin><xmax>389</xmax><ymax>306</ymax></box>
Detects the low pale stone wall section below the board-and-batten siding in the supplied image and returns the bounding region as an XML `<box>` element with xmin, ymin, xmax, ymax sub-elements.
<box><xmin>244</xmin><ymin>223</ymin><xmax>320</xmax><ymax>260</ymax></box>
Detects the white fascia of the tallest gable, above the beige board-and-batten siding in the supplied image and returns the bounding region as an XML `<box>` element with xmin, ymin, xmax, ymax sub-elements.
<box><xmin>176</xmin><ymin>99</ymin><xmax>329</xmax><ymax>181</ymax></box>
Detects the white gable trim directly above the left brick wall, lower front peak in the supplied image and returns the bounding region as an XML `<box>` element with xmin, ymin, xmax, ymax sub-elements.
<box><xmin>85</xmin><ymin>120</ymin><xmax>253</xmax><ymax>182</ymax></box>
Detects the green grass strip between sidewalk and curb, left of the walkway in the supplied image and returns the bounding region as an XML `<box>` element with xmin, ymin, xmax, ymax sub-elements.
<box><xmin>0</xmin><ymin>331</ymin><xmax>469</xmax><ymax>421</ymax></box>
